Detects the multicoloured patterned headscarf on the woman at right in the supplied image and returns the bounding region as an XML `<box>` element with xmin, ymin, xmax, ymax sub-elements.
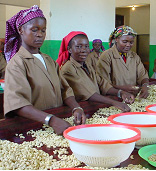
<box><xmin>109</xmin><ymin>25</ymin><xmax>137</xmax><ymax>47</ymax></box>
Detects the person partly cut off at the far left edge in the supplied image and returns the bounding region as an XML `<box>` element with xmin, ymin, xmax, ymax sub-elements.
<box><xmin>0</xmin><ymin>39</ymin><xmax>7</xmax><ymax>79</ymax></box>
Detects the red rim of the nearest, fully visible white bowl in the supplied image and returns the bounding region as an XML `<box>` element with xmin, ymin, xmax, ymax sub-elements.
<box><xmin>63</xmin><ymin>124</ymin><xmax>141</xmax><ymax>144</ymax></box>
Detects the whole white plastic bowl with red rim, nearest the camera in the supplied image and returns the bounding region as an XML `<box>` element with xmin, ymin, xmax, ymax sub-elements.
<box><xmin>63</xmin><ymin>124</ymin><xmax>140</xmax><ymax>168</ymax></box>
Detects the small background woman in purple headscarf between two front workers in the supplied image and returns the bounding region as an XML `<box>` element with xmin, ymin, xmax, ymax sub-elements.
<box><xmin>86</xmin><ymin>39</ymin><xmax>105</xmax><ymax>70</ymax></box>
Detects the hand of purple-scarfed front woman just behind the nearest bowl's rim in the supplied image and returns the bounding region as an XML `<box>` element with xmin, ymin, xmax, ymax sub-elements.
<box><xmin>73</xmin><ymin>109</ymin><xmax>86</xmax><ymax>125</ymax></box>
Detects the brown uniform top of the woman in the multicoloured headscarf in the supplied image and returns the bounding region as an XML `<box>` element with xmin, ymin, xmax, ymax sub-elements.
<box><xmin>97</xmin><ymin>45</ymin><xmax>149</xmax><ymax>85</ymax></box>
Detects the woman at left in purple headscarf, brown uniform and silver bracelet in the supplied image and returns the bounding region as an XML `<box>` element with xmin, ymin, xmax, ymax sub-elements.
<box><xmin>4</xmin><ymin>5</ymin><xmax>86</xmax><ymax>134</ymax></box>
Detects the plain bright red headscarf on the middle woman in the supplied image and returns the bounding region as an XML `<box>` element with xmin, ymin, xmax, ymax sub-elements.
<box><xmin>56</xmin><ymin>31</ymin><xmax>87</xmax><ymax>67</ymax></box>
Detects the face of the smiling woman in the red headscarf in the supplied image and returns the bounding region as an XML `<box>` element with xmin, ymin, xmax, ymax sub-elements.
<box><xmin>68</xmin><ymin>36</ymin><xmax>90</xmax><ymax>64</ymax></box>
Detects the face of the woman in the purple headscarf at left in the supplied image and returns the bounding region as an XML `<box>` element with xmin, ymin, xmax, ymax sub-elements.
<box><xmin>19</xmin><ymin>18</ymin><xmax>46</xmax><ymax>53</ymax></box>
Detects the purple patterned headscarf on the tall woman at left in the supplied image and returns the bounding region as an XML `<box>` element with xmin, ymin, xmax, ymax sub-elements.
<box><xmin>4</xmin><ymin>5</ymin><xmax>45</xmax><ymax>62</ymax></box>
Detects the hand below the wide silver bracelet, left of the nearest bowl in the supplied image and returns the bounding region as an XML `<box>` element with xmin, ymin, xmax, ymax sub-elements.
<box><xmin>50</xmin><ymin>116</ymin><xmax>71</xmax><ymax>135</ymax></box>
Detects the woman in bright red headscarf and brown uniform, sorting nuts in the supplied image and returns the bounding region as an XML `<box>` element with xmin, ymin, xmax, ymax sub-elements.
<box><xmin>58</xmin><ymin>32</ymin><xmax>134</xmax><ymax>111</ymax></box>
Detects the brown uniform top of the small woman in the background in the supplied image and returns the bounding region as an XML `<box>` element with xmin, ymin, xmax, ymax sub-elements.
<box><xmin>86</xmin><ymin>51</ymin><xmax>102</xmax><ymax>70</ymax></box>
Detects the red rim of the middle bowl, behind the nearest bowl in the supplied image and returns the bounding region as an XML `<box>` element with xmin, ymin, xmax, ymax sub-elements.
<box><xmin>108</xmin><ymin>112</ymin><xmax>156</xmax><ymax>127</ymax></box>
